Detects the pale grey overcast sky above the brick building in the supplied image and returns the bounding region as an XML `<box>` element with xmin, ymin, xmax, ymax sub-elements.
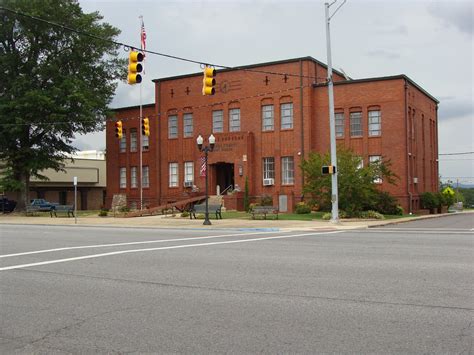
<box><xmin>74</xmin><ymin>0</ymin><xmax>474</xmax><ymax>184</ymax></box>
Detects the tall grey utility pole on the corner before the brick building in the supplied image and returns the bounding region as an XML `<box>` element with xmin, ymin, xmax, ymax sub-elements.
<box><xmin>324</xmin><ymin>0</ymin><xmax>346</xmax><ymax>224</ymax></box>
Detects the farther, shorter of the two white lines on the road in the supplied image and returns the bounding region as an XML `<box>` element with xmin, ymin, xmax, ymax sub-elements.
<box><xmin>0</xmin><ymin>231</ymin><xmax>286</xmax><ymax>259</ymax></box>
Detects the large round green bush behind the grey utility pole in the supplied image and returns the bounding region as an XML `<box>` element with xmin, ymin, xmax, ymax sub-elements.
<box><xmin>301</xmin><ymin>147</ymin><xmax>398</xmax><ymax>216</ymax></box>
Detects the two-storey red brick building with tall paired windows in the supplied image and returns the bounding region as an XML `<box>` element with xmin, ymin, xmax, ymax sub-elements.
<box><xmin>106</xmin><ymin>57</ymin><xmax>438</xmax><ymax>211</ymax></box>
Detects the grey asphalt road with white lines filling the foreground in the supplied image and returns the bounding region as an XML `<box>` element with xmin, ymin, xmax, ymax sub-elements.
<box><xmin>0</xmin><ymin>215</ymin><xmax>474</xmax><ymax>354</ymax></box>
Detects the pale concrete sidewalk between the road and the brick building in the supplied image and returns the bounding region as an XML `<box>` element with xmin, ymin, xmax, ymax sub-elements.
<box><xmin>0</xmin><ymin>212</ymin><xmax>466</xmax><ymax>230</ymax></box>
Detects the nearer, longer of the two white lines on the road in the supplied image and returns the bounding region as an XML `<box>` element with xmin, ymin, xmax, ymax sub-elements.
<box><xmin>0</xmin><ymin>231</ymin><xmax>343</xmax><ymax>271</ymax></box>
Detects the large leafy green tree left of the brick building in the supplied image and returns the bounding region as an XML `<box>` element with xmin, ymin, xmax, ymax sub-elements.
<box><xmin>0</xmin><ymin>0</ymin><xmax>126</xmax><ymax>208</ymax></box>
